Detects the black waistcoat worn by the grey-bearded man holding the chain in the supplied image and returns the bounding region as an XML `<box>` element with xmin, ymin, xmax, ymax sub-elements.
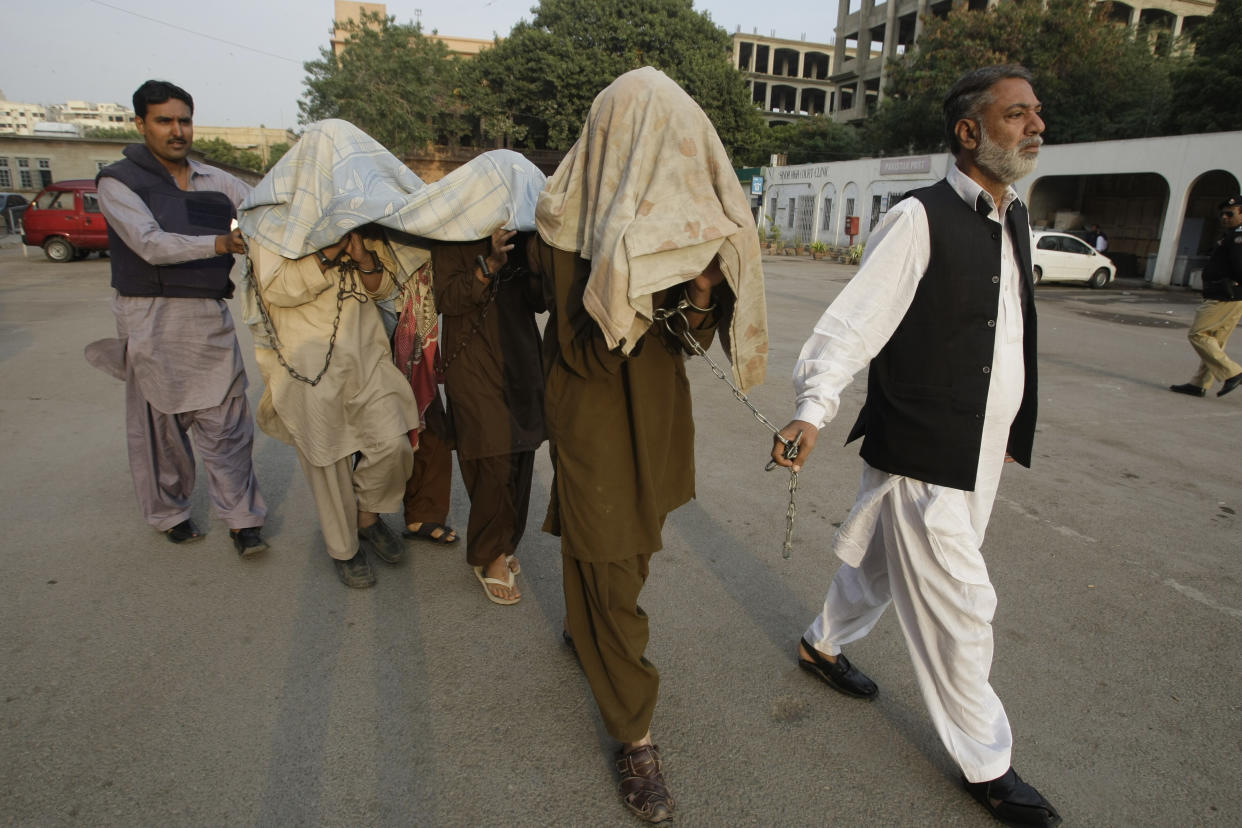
<box><xmin>846</xmin><ymin>180</ymin><xmax>1037</xmax><ymax>492</ymax></box>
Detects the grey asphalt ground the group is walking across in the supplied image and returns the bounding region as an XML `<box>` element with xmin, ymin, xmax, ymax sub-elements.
<box><xmin>0</xmin><ymin>240</ymin><xmax>1242</xmax><ymax>826</ymax></box>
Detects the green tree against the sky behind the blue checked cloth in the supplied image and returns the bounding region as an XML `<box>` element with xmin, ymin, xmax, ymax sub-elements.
<box><xmin>298</xmin><ymin>12</ymin><xmax>473</xmax><ymax>155</ymax></box>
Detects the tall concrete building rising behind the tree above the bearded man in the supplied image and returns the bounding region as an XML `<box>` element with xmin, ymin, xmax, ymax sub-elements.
<box><xmin>828</xmin><ymin>0</ymin><xmax>1216</xmax><ymax>122</ymax></box>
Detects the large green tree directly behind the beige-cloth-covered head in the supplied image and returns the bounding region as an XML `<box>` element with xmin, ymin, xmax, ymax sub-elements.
<box><xmin>468</xmin><ymin>0</ymin><xmax>763</xmax><ymax>155</ymax></box>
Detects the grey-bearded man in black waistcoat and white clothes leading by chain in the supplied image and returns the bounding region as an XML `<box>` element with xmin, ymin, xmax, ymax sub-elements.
<box><xmin>773</xmin><ymin>66</ymin><xmax>1061</xmax><ymax>826</ymax></box>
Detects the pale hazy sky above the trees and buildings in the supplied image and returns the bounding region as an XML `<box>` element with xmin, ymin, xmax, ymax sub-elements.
<box><xmin>0</xmin><ymin>0</ymin><xmax>836</xmax><ymax>129</ymax></box>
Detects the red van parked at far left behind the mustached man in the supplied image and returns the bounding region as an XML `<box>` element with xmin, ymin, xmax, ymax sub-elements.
<box><xmin>21</xmin><ymin>179</ymin><xmax>108</xmax><ymax>262</ymax></box>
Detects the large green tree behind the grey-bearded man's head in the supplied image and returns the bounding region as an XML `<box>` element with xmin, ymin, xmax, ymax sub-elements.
<box><xmin>864</xmin><ymin>0</ymin><xmax>1174</xmax><ymax>153</ymax></box>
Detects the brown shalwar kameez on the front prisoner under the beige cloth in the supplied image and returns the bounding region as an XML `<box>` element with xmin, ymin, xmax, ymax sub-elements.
<box><xmin>539</xmin><ymin>242</ymin><xmax>728</xmax><ymax>742</ymax></box>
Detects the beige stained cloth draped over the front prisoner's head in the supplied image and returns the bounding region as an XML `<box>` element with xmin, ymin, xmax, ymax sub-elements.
<box><xmin>535</xmin><ymin>66</ymin><xmax>768</xmax><ymax>390</ymax></box>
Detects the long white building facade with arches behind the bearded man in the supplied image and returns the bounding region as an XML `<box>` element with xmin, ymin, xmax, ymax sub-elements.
<box><xmin>758</xmin><ymin>132</ymin><xmax>1242</xmax><ymax>286</ymax></box>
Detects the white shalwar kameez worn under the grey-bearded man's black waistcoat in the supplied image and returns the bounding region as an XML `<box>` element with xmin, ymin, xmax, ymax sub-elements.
<box><xmin>794</xmin><ymin>166</ymin><xmax>1030</xmax><ymax>782</ymax></box>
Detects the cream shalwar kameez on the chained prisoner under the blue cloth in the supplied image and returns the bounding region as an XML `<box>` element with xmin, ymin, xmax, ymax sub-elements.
<box><xmin>250</xmin><ymin>241</ymin><xmax>419</xmax><ymax>560</ymax></box>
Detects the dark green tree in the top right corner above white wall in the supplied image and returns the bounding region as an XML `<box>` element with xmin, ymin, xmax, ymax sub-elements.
<box><xmin>1169</xmin><ymin>0</ymin><xmax>1242</xmax><ymax>133</ymax></box>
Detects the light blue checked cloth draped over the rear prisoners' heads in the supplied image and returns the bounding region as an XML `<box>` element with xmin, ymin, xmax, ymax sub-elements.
<box><xmin>238</xmin><ymin>119</ymin><xmax>545</xmax><ymax>282</ymax></box>
